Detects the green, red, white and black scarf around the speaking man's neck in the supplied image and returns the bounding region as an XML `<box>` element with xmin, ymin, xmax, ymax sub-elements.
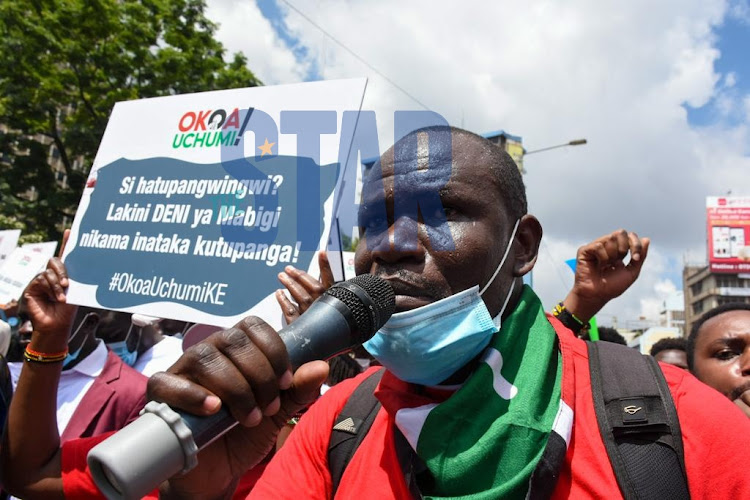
<box><xmin>376</xmin><ymin>287</ymin><xmax>573</xmax><ymax>499</ymax></box>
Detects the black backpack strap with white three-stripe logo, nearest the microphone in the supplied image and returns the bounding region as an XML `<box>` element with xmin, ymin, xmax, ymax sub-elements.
<box><xmin>328</xmin><ymin>368</ymin><xmax>385</xmax><ymax>496</ymax></box>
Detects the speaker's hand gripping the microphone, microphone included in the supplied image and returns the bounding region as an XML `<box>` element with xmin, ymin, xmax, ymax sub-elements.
<box><xmin>88</xmin><ymin>275</ymin><xmax>395</xmax><ymax>498</ymax></box>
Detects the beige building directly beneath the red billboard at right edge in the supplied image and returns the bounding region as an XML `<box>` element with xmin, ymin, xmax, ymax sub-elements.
<box><xmin>682</xmin><ymin>266</ymin><xmax>750</xmax><ymax>334</ymax></box>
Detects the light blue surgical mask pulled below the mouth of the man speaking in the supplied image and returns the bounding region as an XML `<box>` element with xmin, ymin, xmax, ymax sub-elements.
<box><xmin>364</xmin><ymin>221</ymin><xmax>520</xmax><ymax>386</ymax></box>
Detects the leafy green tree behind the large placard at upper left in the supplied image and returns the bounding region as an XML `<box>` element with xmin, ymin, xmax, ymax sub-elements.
<box><xmin>0</xmin><ymin>0</ymin><xmax>261</xmax><ymax>240</ymax></box>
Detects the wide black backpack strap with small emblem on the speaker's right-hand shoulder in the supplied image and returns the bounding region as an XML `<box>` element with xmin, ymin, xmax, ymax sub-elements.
<box><xmin>587</xmin><ymin>342</ymin><xmax>690</xmax><ymax>500</ymax></box>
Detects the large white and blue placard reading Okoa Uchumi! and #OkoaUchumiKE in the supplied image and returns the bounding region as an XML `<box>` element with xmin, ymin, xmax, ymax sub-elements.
<box><xmin>64</xmin><ymin>79</ymin><xmax>366</xmax><ymax>328</ymax></box>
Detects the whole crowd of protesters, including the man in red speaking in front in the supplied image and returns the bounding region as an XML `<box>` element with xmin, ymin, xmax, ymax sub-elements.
<box><xmin>0</xmin><ymin>128</ymin><xmax>750</xmax><ymax>499</ymax></box>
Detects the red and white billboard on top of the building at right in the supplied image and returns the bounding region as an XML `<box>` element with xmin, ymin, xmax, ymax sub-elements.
<box><xmin>706</xmin><ymin>196</ymin><xmax>750</xmax><ymax>274</ymax></box>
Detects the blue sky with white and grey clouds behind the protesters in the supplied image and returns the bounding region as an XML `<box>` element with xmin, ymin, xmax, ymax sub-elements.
<box><xmin>207</xmin><ymin>0</ymin><xmax>750</xmax><ymax>326</ymax></box>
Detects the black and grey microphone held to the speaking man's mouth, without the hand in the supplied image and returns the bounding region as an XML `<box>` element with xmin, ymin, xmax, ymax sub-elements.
<box><xmin>88</xmin><ymin>274</ymin><xmax>396</xmax><ymax>499</ymax></box>
